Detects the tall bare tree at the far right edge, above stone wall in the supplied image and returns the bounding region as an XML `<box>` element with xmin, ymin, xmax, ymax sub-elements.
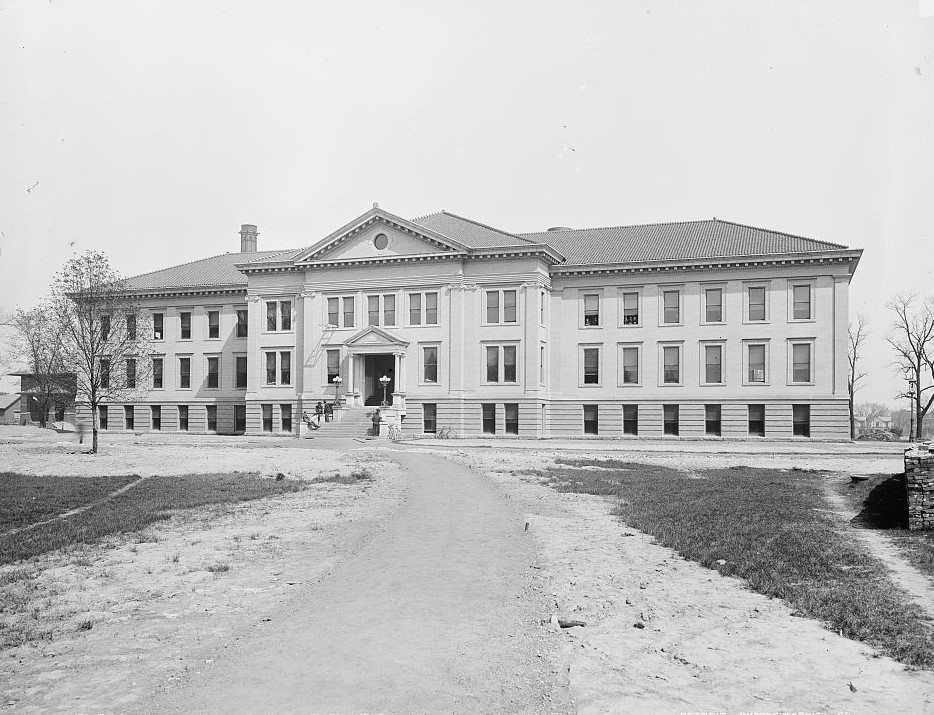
<box><xmin>886</xmin><ymin>293</ymin><xmax>934</xmax><ymax>436</ymax></box>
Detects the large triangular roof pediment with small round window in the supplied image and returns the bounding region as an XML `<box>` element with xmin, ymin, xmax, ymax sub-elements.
<box><xmin>295</xmin><ymin>207</ymin><xmax>468</xmax><ymax>264</ymax></box>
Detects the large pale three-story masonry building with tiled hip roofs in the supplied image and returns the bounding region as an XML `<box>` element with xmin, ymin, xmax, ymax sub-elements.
<box><xmin>108</xmin><ymin>206</ymin><xmax>861</xmax><ymax>439</ymax></box>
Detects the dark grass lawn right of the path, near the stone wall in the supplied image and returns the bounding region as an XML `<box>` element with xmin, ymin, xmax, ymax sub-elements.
<box><xmin>544</xmin><ymin>459</ymin><xmax>934</xmax><ymax>669</ymax></box>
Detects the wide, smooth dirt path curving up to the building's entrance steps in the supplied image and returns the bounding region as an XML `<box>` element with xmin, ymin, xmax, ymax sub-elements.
<box><xmin>146</xmin><ymin>451</ymin><xmax>569</xmax><ymax>713</ymax></box>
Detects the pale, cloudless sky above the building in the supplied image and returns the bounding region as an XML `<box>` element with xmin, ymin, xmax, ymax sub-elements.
<box><xmin>0</xmin><ymin>0</ymin><xmax>934</xmax><ymax>404</ymax></box>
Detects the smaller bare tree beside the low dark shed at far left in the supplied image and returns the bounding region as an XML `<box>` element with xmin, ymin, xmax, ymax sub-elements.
<box><xmin>9</xmin><ymin>302</ymin><xmax>75</xmax><ymax>427</ymax></box>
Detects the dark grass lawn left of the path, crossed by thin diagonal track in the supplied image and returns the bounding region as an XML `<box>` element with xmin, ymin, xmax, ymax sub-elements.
<box><xmin>0</xmin><ymin>473</ymin><xmax>303</xmax><ymax>564</ymax></box>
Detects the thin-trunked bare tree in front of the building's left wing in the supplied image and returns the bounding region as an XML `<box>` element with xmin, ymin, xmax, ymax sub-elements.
<box><xmin>52</xmin><ymin>251</ymin><xmax>152</xmax><ymax>453</ymax></box>
